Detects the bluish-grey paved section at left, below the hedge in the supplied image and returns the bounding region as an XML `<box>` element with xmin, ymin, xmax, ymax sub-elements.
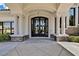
<box><xmin>0</xmin><ymin>42</ymin><xmax>19</xmax><ymax>55</ymax></box>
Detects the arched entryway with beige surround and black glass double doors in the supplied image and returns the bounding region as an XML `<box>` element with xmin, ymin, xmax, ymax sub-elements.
<box><xmin>26</xmin><ymin>9</ymin><xmax>55</xmax><ymax>38</ymax></box>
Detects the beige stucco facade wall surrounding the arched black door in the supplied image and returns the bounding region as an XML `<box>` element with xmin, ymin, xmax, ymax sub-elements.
<box><xmin>0</xmin><ymin>3</ymin><xmax>76</xmax><ymax>36</ymax></box>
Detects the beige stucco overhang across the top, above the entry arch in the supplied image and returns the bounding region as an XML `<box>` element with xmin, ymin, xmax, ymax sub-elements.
<box><xmin>2</xmin><ymin>3</ymin><xmax>73</xmax><ymax>14</ymax></box>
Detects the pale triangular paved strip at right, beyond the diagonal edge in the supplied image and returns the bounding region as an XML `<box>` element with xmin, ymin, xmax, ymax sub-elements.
<box><xmin>58</xmin><ymin>42</ymin><xmax>79</xmax><ymax>56</ymax></box>
